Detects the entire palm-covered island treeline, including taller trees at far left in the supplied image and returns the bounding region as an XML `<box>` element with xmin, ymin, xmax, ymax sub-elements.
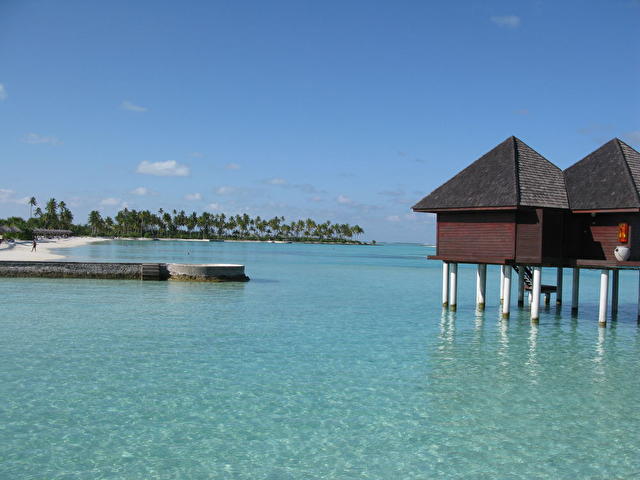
<box><xmin>0</xmin><ymin>197</ymin><xmax>364</xmax><ymax>244</ymax></box>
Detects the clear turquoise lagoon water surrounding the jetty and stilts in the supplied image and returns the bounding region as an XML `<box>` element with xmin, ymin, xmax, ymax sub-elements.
<box><xmin>0</xmin><ymin>242</ymin><xmax>640</xmax><ymax>480</ymax></box>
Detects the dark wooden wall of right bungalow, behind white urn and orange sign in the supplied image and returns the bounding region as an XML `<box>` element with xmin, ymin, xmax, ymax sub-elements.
<box><xmin>566</xmin><ymin>213</ymin><xmax>640</xmax><ymax>264</ymax></box>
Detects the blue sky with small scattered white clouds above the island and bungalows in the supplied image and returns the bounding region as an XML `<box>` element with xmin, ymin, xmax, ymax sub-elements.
<box><xmin>0</xmin><ymin>0</ymin><xmax>640</xmax><ymax>242</ymax></box>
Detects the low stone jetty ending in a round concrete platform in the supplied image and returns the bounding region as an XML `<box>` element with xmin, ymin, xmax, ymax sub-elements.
<box><xmin>0</xmin><ymin>261</ymin><xmax>249</xmax><ymax>282</ymax></box>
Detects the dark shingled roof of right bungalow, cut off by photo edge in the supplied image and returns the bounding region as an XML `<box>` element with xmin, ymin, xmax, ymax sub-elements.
<box><xmin>564</xmin><ymin>138</ymin><xmax>640</xmax><ymax>210</ymax></box>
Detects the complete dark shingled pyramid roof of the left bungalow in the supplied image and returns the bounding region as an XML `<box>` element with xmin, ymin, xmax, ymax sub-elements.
<box><xmin>413</xmin><ymin>137</ymin><xmax>569</xmax><ymax>212</ymax></box>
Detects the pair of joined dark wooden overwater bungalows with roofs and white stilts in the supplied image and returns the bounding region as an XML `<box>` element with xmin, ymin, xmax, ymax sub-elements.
<box><xmin>413</xmin><ymin>137</ymin><xmax>640</xmax><ymax>326</ymax></box>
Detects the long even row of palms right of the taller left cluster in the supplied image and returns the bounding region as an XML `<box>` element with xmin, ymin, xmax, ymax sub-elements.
<box><xmin>88</xmin><ymin>208</ymin><xmax>364</xmax><ymax>242</ymax></box>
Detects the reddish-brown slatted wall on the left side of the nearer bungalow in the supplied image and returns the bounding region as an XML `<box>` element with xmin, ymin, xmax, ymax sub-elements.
<box><xmin>437</xmin><ymin>211</ymin><xmax>516</xmax><ymax>262</ymax></box>
